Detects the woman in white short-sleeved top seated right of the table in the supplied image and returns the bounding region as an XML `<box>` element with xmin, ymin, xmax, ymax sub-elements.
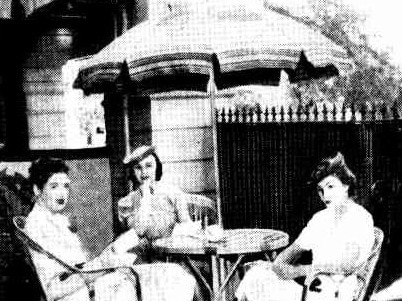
<box><xmin>236</xmin><ymin>153</ymin><xmax>374</xmax><ymax>301</ymax></box>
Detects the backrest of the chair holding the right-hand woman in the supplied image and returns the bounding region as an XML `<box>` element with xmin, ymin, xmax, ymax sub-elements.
<box><xmin>356</xmin><ymin>227</ymin><xmax>384</xmax><ymax>301</ymax></box>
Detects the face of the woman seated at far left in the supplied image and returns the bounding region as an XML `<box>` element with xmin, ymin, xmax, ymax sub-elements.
<box><xmin>40</xmin><ymin>172</ymin><xmax>70</xmax><ymax>212</ymax></box>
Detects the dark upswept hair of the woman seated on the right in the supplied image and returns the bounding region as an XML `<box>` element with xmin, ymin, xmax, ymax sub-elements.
<box><xmin>311</xmin><ymin>152</ymin><xmax>356</xmax><ymax>196</ymax></box>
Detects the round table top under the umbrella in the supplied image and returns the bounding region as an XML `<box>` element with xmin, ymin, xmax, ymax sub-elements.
<box><xmin>153</xmin><ymin>229</ymin><xmax>289</xmax><ymax>255</ymax></box>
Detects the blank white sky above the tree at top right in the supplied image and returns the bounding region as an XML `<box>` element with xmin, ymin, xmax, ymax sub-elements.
<box><xmin>265</xmin><ymin>0</ymin><xmax>402</xmax><ymax>69</ymax></box>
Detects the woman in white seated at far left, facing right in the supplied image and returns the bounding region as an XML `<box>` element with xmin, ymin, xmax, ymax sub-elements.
<box><xmin>25</xmin><ymin>158</ymin><xmax>195</xmax><ymax>301</ymax></box>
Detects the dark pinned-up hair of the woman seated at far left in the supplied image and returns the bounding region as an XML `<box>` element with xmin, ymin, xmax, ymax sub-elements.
<box><xmin>29</xmin><ymin>157</ymin><xmax>69</xmax><ymax>189</ymax></box>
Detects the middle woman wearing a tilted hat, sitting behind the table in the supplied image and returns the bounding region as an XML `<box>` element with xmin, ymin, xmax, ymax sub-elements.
<box><xmin>118</xmin><ymin>146</ymin><xmax>200</xmax><ymax>261</ymax></box>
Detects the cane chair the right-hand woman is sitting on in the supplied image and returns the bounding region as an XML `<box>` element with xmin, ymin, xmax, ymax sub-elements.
<box><xmin>302</xmin><ymin>227</ymin><xmax>384</xmax><ymax>301</ymax></box>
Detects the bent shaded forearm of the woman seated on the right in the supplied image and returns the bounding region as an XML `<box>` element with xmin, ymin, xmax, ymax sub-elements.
<box><xmin>272</xmin><ymin>243</ymin><xmax>311</xmax><ymax>279</ymax></box>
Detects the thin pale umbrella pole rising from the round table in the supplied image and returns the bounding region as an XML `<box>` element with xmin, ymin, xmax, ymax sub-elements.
<box><xmin>208</xmin><ymin>71</ymin><xmax>223</xmax><ymax>227</ymax></box>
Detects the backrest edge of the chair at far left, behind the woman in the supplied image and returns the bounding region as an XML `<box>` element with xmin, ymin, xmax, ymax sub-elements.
<box><xmin>13</xmin><ymin>216</ymin><xmax>47</xmax><ymax>301</ymax></box>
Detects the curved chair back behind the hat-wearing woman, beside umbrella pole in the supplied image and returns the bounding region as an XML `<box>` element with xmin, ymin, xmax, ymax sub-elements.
<box><xmin>186</xmin><ymin>193</ymin><xmax>218</xmax><ymax>226</ymax></box>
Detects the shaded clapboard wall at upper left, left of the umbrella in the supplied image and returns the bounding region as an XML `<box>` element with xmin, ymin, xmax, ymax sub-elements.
<box><xmin>23</xmin><ymin>27</ymin><xmax>74</xmax><ymax>150</ymax></box>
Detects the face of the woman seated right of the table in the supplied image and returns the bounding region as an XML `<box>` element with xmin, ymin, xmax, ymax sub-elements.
<box><xmin>317</xmin><ymin>175</ymin><xmax>349</xmax><ymax>207</ymax></box>
